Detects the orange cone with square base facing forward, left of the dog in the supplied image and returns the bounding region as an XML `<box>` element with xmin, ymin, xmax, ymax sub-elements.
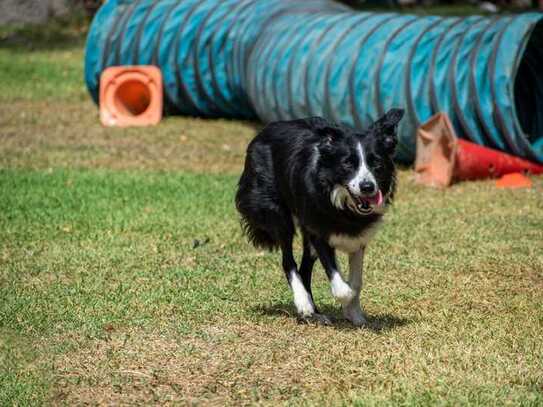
<box><xmin>100</xmin><ymin>65</ymin><xmax>163</xmax><ymax>127</ymax></box>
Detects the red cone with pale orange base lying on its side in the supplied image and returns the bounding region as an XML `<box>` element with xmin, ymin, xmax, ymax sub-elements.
<box><xmin>415</xmin><ymin>113</ymin><xmax>543</xmax><ymax>187</ymax></box>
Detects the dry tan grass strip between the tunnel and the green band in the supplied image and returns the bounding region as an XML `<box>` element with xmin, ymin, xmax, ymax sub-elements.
<box><xmin>0</xmin><ymin>101</ymin><xmax>260</xmax><ymax>174</ymax></box>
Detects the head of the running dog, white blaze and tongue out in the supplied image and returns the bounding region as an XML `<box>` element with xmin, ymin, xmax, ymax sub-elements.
<box><xmin>317</xmin><ymin>109</ymin><xmax>404</xmax><ymax>216</ymax></box>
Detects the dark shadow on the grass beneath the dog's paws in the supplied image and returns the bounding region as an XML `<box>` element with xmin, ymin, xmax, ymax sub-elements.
<box><xmin>253</xmin><ymin>303</ymin><xmax>414</xmax><ymax>333</ymax></box>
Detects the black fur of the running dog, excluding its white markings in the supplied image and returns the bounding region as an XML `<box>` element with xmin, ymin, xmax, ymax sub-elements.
<box><xmin>236</xmin><ymin>109</ymin><xmax>403</xmax><ymax>324</ymax></box>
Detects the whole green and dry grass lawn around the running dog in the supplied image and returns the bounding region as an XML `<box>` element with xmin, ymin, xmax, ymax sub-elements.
<box><xmin>0</xmin><ymin>15</ymin><xmax>543</xmax><ymax>406</ymax></box>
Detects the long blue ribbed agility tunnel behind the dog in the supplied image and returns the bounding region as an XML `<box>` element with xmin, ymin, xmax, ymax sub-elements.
<box><xmin>85</xmin><ymin>0</ymin><xmax>543</xmax><ymax>163</ymax></box>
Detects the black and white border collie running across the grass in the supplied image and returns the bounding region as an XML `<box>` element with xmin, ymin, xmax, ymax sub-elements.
<box><xmin>236</xmin><ymin>109</ymin><xmax>403</xmax><ymax>326</ymax></box>
